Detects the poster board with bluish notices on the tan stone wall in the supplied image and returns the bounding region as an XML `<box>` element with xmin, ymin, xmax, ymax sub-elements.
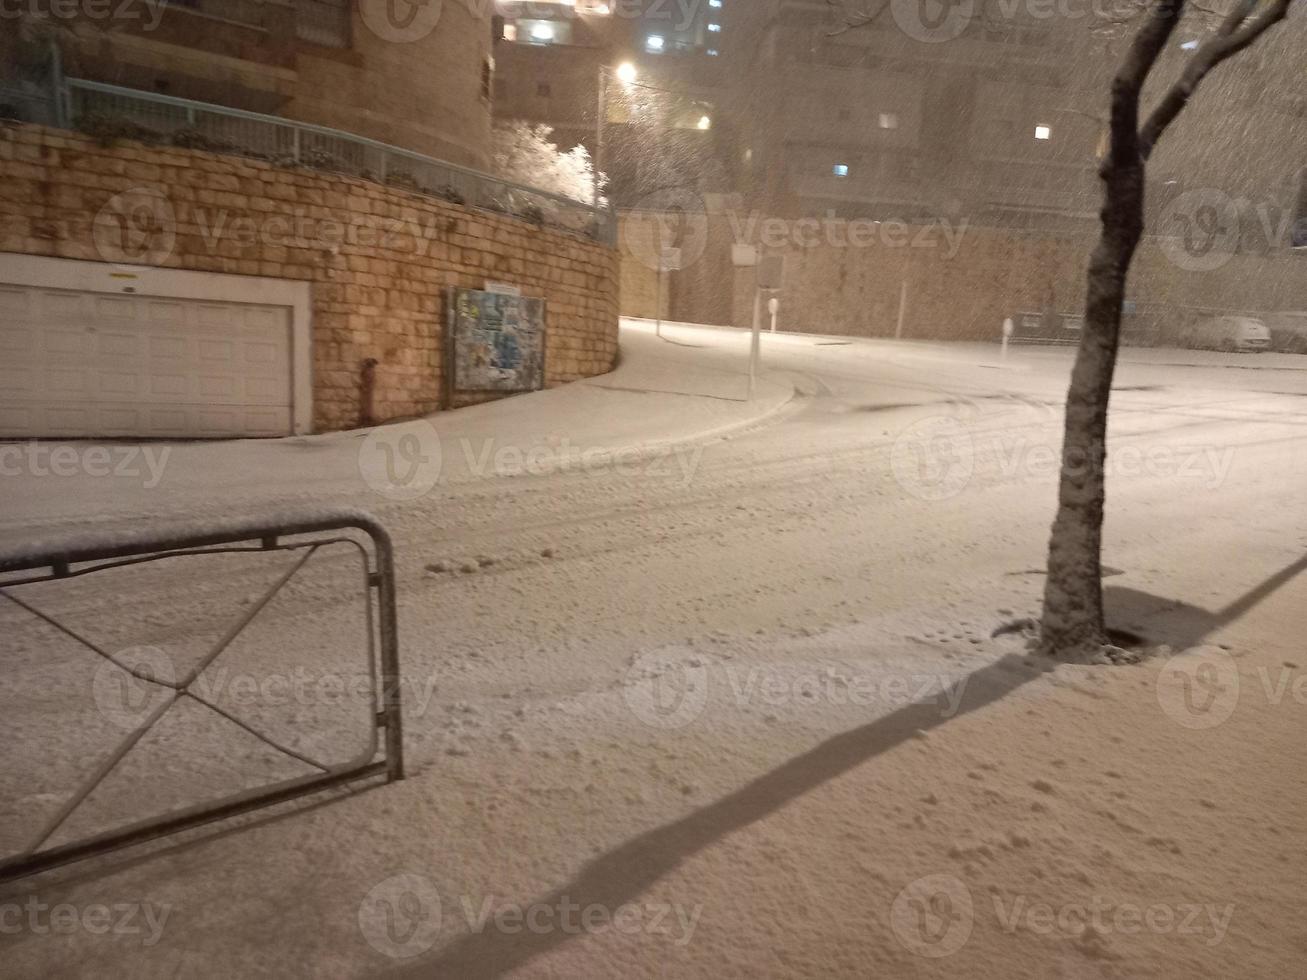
<box><xmin>446</xmin><ymin>287</ymin><xmax>545</xmax><ymax>396</ymax></box>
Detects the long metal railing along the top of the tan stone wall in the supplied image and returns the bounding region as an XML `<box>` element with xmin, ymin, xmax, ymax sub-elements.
<box><xmin>61</xmin><ymin>78</ymin><xmax>617</xmax><ymax>246</ymax></box>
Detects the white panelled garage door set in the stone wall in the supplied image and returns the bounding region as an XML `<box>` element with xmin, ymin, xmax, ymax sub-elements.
<box><xmin>0</xmin><ymin>282</ymin><xmax>293</xmax><ymax>438</ymax></box>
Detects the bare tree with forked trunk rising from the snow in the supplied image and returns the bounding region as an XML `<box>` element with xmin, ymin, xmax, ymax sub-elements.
<box><xmin>1039</xmin><ymin>0</ymin><xmax>1291</xmax><ymax>660</ymax></box>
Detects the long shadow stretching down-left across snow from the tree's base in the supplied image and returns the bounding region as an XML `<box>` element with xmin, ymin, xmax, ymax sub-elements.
<box><xmin>381</xmin><ymin>655</ymin><xmax>1055</xmax><ymax>980</ymax></box>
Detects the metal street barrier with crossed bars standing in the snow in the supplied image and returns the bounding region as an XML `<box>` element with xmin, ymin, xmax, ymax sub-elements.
<box><xmin>0</xmin><ymin>508</ymin><xmax>404</xmax><ymax>881</ymax></box>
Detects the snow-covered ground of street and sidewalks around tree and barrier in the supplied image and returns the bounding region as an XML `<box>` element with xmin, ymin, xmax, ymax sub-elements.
<box><xmin>0</xmin><ymin>324</ymin><xmax>1307</xmax><ymax>980</ymax></box>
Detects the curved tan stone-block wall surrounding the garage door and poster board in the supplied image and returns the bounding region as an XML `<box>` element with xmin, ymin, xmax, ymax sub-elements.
<box><xmin>0</xmin><ymin>125</ymin><xmax>618</xmax><ymax>430</ymax></box>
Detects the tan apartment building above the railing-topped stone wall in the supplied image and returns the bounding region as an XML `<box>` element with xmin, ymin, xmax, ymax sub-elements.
<box><xmin>5</xmin><ymin>0</ymin><xmax>493</xmax><ymax>167</ymax></box>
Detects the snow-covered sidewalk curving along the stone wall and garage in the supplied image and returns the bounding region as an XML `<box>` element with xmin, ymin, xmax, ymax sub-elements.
<box><xmin>0</xmin><ymin>321</ymin><xmax>795</xmax><ymax>540</ymax></box>
